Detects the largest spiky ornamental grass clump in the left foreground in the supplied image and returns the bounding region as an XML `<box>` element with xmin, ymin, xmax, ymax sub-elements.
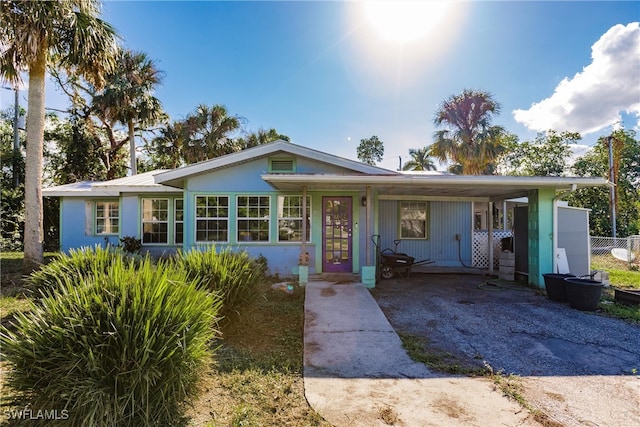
<box><xmin>0</xmin><ymin>258</ymin><xmax>220</xmax><ymax>426</ymax></box>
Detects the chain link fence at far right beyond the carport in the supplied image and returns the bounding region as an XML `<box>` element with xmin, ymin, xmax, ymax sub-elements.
<box><xmin>591</xmin><ymin>236</ymin><xmax>640</xmax><ymax>270</ymax></box>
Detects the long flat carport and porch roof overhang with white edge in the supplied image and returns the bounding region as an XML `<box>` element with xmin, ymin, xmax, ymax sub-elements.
<box><xmin>262</xmin><ymin>174</ymin><xmax>611</xmax><ymax>201</ymax></box>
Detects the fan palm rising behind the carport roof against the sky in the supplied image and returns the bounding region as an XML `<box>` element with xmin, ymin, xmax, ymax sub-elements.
<box><xmin>429</xmin><ymin>89</ymin><xmax>505</xmax><ymax>175</ymax></box>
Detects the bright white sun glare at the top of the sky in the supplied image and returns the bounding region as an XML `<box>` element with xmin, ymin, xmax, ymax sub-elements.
<box><xmin>363</xmin><ymin>0</ymin><xmax>451</xmax><ymax>43</ymax></box>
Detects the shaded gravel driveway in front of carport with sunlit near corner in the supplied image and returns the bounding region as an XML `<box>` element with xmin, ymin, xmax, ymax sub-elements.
<box><xmin>372</xmin><ymin>273</ymin><xmax>640</xmax><ymax>426</ymax></box>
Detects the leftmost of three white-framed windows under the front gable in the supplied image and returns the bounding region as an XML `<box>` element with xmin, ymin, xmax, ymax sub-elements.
<box><xmin>196</xmin><ymin>196</ymin><xmax>229</xmax><ymax>242</ymax></box>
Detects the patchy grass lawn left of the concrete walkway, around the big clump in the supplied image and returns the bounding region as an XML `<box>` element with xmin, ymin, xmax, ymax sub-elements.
<box><xmin>0</xmin><ymin>253</ymin><xmax>331</xmax><ymax>427</ymax></box>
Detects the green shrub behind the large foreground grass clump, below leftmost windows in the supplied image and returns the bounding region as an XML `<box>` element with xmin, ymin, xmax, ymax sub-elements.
<box><xmin>27</xmin><ymin>246</ymin><xmax>140</xmax><ymax>294</ymax></box>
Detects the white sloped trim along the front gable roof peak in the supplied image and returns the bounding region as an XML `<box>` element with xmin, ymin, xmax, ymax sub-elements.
<box><xmin>155</xmin><ymin>140</ymin><xmax>397</xmax><ymax>186</ymax></box>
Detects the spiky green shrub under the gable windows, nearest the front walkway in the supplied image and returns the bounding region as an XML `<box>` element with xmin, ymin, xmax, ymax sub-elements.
<box><xmin>175</xmin><ymin>248</ymin><xmax>265</xmax><ymax>316</ymax></box>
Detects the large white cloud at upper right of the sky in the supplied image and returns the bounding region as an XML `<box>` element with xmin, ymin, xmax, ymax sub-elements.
<box><xmin>513</xmin><ymin>22</ymin><xmax>640</xmax><ymax>135</ymax></box>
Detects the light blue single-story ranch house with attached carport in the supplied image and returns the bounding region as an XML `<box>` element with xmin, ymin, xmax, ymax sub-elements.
<box><xmin>43</xmin><ymin>140</ymin><xmax>608</xmax><ymax>286</ymax></box>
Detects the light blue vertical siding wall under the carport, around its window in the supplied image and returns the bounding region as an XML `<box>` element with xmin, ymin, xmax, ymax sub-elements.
<box><xmin>378</xmin><ymin>200</ymin><xmax>471</xmax><ymax>266</ymax></box>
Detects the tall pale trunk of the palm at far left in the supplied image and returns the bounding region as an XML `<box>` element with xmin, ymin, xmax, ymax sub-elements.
<box><xmin>22</xmin><ymin>45</ymin><xmax>47</xmax><ymax>274</ymax></box>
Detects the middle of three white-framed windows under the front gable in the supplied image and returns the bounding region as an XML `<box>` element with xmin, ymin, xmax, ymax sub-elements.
<box><xmin>236</xmin><ymin>196</ymin><xmax>270</xmax><ymax>242</ymax></box>
